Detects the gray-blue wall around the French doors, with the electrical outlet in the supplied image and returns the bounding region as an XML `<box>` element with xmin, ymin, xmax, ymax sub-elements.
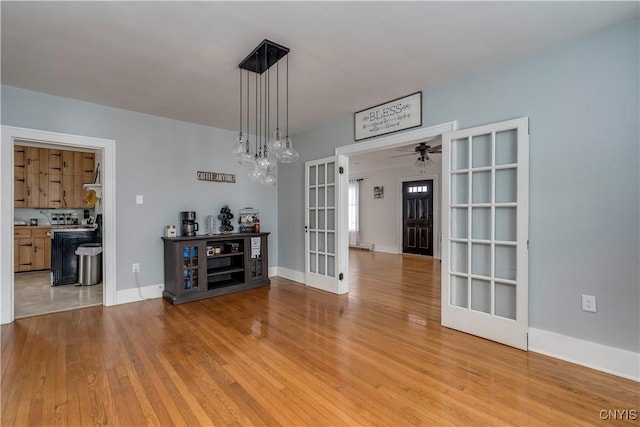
<box><xmin>278</xmin><ymin>20</ymin><xmax>640</xmax><ymax>353</ymax></box>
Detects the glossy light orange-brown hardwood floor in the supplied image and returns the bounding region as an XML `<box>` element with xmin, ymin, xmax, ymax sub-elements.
<box><xmin>1</xmin><ymin>251</ymin><xmax>640</xmax><ymax>426</ymax></box>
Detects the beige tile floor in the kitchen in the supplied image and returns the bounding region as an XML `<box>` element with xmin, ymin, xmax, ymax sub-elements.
<box><xmin>14</xmin><ymin>271</ymin><xmax>103</xmax><ymax>319</ymax></box>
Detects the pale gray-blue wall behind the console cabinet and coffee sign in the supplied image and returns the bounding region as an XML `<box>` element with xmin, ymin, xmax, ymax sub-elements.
<box><xmin>2</xmin><ymin>86</ymin><xmax>278</xmax><ymax>290</ymax></box>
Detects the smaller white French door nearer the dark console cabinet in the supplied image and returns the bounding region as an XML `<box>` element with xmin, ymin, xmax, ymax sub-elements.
<box><xmin>304</xmin><ymin>156</ymin><xmax>349</xmax><ymax>294</ymax></box>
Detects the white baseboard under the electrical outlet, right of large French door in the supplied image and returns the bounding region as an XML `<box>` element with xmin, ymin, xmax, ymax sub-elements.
<box><xmin>529</xmin><ymin>328</ymin><xmax>640</xmax><ymax>381</ymax></box>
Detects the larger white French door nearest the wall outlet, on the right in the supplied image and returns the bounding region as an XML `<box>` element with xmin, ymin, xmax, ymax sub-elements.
<box><xmin>442</xmin><ymin>118</ymin><xmax>529</xmax><ymax>350</ymax></box>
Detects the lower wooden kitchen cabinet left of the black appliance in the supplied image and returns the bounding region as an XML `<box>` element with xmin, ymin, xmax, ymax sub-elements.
<box><xmin>13</xmin><ymin>227</ymin><xmax>51</xmax><ymax>273</ymax></box>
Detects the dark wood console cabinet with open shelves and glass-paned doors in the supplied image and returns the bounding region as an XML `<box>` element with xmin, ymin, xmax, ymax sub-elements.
<box><xmin>162</xmin><ymin>233</ymin><xmax>271</xmax><ymax>304</ymax></box>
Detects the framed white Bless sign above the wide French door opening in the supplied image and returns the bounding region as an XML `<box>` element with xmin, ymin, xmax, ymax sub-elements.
<box><xmin>353</xmin><ymin>92</ymin><xmax>422</xmax><ymax>141</ymax></box>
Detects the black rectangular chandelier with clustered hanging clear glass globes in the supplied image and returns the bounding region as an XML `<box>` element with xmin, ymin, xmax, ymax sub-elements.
<box><xmin>233</xmin><ymin>39</ymin><xmax>299</xmax><ymax>185</ymax></box>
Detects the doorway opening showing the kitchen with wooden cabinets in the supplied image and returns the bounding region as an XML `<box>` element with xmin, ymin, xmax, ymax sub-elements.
<box><xmin>13</xmin><ymin>139</ymin><xmax>103</xmax><ymax>319</ymax></box>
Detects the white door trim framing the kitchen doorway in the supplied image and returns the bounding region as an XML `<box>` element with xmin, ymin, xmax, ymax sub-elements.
<box><xmin>0</xmin><ymin>126</ymin><xmax>116</xmax><ymax>324</ymax></box>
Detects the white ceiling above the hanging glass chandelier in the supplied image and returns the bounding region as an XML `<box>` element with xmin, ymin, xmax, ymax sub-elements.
<box><xmin>1</xmin><ymin>1</ymin><xmax>639</xmax><ymax>140</ymax></box>
